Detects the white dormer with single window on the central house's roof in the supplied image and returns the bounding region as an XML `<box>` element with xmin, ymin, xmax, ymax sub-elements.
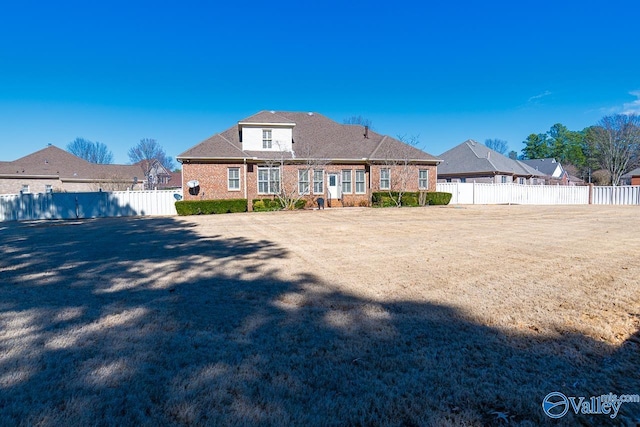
<box><xmin>238</xmin><ymin>122</ymin><xmax>296</xmax><ymax>152</ymax></box>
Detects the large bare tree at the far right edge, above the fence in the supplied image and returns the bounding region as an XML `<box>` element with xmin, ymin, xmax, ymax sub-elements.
<box><xmin>590</xmin><ymin>114</ymin><xmax>640</xmax><ymax>185</ymax></box>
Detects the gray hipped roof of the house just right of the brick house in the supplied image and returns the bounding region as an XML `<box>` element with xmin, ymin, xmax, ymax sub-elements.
<box><xmin>438</xmin><ymin>139</ymin><xmax>544</xmax><ymax>176</ymax></box>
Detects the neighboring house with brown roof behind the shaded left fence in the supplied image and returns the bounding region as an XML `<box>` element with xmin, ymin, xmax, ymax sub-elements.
<box><xmin>0</xmin><ymin>145</ymin><xmax>144</xmax><ymax>194</ymax></box>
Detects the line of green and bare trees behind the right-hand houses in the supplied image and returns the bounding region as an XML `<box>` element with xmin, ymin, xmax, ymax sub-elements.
<box><xmin>485</xmin><ymin>114</ymin><xmax>640</xmax><ymax>185</ymax></box>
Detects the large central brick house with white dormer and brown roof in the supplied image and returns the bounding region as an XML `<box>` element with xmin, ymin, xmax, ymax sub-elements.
<box><xmin>177</xmin><ymin>111</ymin><xmax>439</xmax><ymax>209</ymax></box>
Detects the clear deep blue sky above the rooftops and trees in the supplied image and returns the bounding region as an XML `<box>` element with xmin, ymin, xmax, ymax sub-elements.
<box><xmin>0</xmin><ymin>0</ymin><xmax>640</xmax><ymax>163</ymax></box>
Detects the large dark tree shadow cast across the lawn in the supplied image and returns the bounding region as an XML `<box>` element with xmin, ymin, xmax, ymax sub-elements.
<box><xmin>0</xmin><ymin>218</ymin><xmax>640</xmax><ymax>425</ymax></box>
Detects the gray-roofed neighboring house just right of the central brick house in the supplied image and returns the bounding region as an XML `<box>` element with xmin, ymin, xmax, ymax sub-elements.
<box><xmin>438</xmin><ymin>139</ymin><xmax>546</xmax><ymax>184</ymax></box>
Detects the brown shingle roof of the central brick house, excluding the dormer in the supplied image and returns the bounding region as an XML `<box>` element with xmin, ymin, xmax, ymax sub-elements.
<box><xmin>178</xmin><ymin>111</ymin><xmax>439</xmax><ymax>163</ymax></box>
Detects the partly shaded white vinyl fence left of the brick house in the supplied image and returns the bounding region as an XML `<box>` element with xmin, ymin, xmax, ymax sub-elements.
<box><xmin>0</xmin><ymin>190</ymin><xmax>182</xmax><ymax>221</ymax></box>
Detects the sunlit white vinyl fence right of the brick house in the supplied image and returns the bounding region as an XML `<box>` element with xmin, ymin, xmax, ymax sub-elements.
<box><xmin>437</xmin><ymin>182</ymin><xmax>640</xmax><ymax>205</ymax></box>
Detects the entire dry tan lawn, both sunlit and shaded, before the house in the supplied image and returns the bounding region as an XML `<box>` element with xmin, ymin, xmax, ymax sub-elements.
<box><xmin>0</xmin><ymin>206</ymin><xmax>640</xmax><ymax>426</ymax></box>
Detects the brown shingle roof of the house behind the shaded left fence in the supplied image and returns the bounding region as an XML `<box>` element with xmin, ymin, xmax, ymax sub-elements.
<box><xmin>0</xmin><ymin>145</ymin><xmax>144</xmax><ymax>181</ymax></box>
